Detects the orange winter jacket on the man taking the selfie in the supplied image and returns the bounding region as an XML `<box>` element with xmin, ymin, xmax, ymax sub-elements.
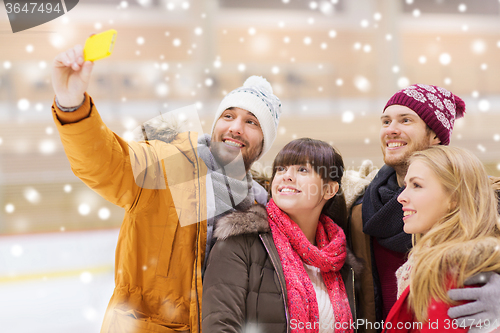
<box><xmin>52</xmin><ymin>95</ymin><xmax>207</xmax><ymax>333</ymax></box>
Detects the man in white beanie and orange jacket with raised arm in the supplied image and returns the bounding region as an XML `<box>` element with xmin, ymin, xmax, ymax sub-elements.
<box><xmin>52</xmin><ymin>46</ymin><xmax>281</xmax><ymax>333</ymax></box>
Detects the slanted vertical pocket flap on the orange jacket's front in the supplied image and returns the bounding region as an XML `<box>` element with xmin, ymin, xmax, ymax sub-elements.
<box><xmin>156</xmin><ymin>207</ymin><xmax>181</xmax><ymax>278</ymax></box>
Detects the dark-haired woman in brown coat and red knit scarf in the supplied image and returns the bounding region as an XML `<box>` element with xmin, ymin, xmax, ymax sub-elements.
<box><xmin>202</xmin><ymin>138</ymin><xmax>360</xmax><ymax>333</ymax></box>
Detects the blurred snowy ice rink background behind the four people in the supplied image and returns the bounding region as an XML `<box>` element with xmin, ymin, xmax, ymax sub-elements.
<box><xmin>0</xmin><ymin>0</ymin><xmax>500</xmax><ymax>333</ymax></box>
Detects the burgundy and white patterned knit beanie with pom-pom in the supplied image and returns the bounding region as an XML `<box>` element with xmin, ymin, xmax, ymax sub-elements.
<box><xmin>384</xmin><ymin>84</ymin><xmax>465</xmax><ymax>145</ymax></box>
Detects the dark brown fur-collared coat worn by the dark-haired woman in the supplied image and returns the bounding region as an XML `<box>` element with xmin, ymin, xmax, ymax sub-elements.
<box><xmin>202</xmin><ymin>205</ymin><xmax>362</xmax><ymax>333</ymax></box>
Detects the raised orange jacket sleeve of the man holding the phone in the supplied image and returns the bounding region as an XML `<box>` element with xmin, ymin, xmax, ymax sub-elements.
<box><xmin>52</xmin><ymin>95</ymin><xmax>156</xmax><ymax>210</ymax></box>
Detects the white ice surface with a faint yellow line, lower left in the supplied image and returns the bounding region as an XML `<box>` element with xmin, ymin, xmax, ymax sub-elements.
<box><xmin>0</xmin><ymin>229</ymin><xmax>118</xmax><ymax>333</ymax></box>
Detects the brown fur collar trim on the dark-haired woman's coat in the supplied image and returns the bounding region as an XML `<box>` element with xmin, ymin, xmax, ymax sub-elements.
<box><xmin>214</xmin><ymin>205</ymin><xmax>363</xmax><ymax>278</ymax></box>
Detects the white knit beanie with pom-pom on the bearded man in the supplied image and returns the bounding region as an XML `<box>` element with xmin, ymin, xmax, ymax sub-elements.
<box><xmin>212</xmin><ymin>75</ymin><xmax>281</xmax><ymax>157</ymax></box>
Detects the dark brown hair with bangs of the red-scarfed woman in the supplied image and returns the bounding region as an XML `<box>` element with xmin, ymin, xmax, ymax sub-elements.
<box><xmin>269</xmin><ymin>138</ymin><xmax>347</xmax><ymax>231</ymax></box>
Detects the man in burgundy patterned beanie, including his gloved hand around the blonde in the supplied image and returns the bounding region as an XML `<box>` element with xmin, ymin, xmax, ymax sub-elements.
<box><xmin>348</xmin><ymin>84</ymin><xmax>500</xmax><ymax>331</ymax></box>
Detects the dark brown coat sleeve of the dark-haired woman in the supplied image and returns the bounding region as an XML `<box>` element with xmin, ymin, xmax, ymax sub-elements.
<box><xmin>202</xmin><ymin>236</ymin><xmax>249</xmax><ymax>333</ymax></box>
